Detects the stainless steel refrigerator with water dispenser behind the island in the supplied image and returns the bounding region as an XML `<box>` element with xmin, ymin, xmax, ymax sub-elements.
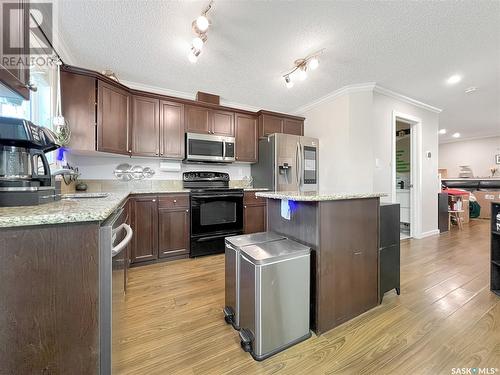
<box><xmin>252</xmin><ymin>133</ymin><xmax>319</xmax><ymax>191</ymax></box>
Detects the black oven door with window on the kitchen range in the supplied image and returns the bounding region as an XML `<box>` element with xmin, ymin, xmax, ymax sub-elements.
<box><xmin>191</xmin><ymin>192</ymin><xmax>243</xmax><ymax>236</ymax></box>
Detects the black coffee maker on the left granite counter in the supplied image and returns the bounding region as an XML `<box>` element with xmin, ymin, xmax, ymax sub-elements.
<box><xmin>0</xmin><ymin>117</ymin><xmax>60</xmax><ymax>207</ymax></box>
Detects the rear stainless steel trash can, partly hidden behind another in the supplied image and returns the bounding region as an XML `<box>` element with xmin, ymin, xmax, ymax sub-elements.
<box><xmin>224</xmin><ymin>232</ymin><xmax>285</xmax><ymax>330</ymax></box>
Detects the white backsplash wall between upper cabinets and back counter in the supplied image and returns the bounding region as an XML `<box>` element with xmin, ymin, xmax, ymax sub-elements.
<box><xmin>66</xmin><ymin>154</ymin><xmax>251</xmax><ymax>180</ymax></box>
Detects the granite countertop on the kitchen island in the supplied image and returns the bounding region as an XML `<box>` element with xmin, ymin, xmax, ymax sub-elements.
<box><xmin>255</xmin><ymin>191</ymin><xmax>387</xmax><ymax>202</ymax></box>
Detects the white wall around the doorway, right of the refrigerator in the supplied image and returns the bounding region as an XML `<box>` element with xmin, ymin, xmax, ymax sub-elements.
<box><xmin>302</xmin><ymin>89</ymin><xmax>439</xmax><ymax>236</ymax></box>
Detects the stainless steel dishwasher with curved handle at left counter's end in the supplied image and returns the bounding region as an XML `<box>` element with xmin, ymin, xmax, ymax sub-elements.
<box><xmin>99</xmin><ymin>206</ymin><xmax>133</xmax><ymax>375</ymax></box>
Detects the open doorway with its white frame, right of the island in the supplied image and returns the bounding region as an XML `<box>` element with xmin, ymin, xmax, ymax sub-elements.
<box><xmin>392</xmin><ymin>112</ymin><xmax>421</xmax><ymax>240</ymax></box>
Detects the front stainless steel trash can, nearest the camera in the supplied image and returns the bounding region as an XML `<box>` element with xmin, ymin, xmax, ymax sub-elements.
<box><xmin>239</xmin><ymin>239</ymin><xmax>311</xmax><ymax>361</ymax></box>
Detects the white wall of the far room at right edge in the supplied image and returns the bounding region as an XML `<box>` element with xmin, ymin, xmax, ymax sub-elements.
<box><xmin>439</xmin><ymin>137</ymin><xmax>500</xmax><ymax>178</ymax></box>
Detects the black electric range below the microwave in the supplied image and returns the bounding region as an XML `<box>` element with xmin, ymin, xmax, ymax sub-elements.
<box><xmin>186</xmin><ymin>172</ymin><xmax>243</xmax><ymax>257</ymax></box>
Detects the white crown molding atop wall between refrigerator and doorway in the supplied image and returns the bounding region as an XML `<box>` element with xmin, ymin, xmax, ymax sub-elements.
<box><xmin>292</xmin><ymin>82</ymin><xmax>442</xmax><ymax>115</ymax></box>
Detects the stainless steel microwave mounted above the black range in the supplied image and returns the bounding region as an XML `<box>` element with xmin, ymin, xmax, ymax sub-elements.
<box><xmin>186</xmin><ymin>133</ymin><xmax>235</xmax><ymax>163</ymax></box>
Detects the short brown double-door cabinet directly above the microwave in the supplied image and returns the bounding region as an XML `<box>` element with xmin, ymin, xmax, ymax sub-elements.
<box><xmin>185</xmin><ymin>105</ymin><xmax>234</xmax><ymax>137</ymax></box>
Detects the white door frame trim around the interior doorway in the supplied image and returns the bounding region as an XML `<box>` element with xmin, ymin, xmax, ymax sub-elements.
<box><xmin>391</xmin><ymin>111</ymin><xmax>422</xmax><ymax>238</ymax></box>
